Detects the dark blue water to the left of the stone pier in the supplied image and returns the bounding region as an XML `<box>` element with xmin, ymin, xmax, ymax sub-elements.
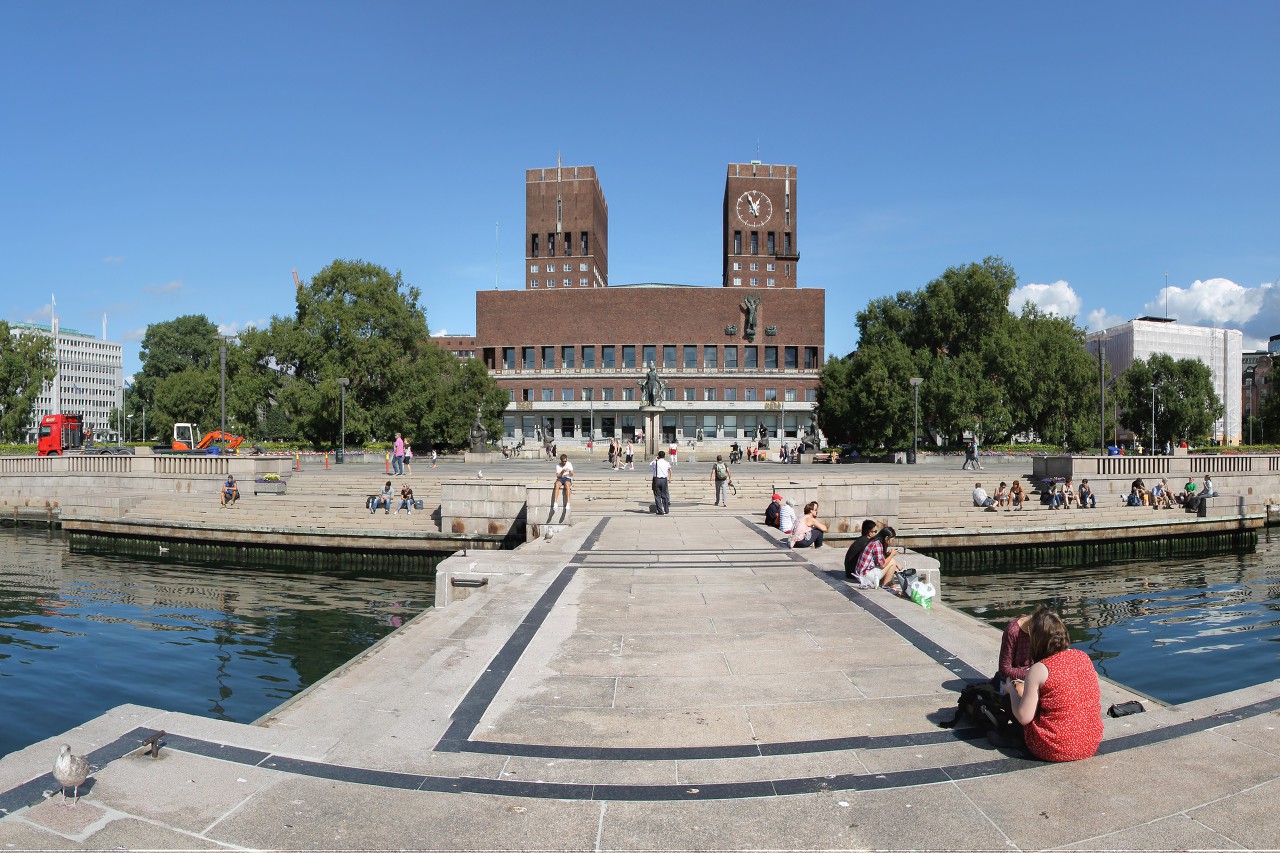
<box><xmin>0</xmin><ymin>529</ymin><xmax>434</xmax><ymax>754</ymax></box>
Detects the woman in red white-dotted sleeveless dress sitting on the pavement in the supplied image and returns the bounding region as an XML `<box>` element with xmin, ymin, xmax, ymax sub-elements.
<box><xmin>1005</xmin><ymin>607</ymin><xmax>1102</xmax><ymax>761</ymax></box>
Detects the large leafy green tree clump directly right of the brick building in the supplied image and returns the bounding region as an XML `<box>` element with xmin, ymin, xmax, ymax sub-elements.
<box><xmin>818</xmin><ymin>257</ymin><xmax>1097</xmax><ymax>450</ymax></box>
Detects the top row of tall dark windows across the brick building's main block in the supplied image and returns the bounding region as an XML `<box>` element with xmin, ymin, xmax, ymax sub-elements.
<box><xmin>502</xmin><ymin>343</ymin><xmax>822</xmax><ymax>370</ymax></box>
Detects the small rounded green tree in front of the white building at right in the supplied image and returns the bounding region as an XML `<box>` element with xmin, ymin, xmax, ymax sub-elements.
<box><xmin>1116</xmin><ymin>352</ymin><xmax>1222</xmax><ymax>444</ymax></box>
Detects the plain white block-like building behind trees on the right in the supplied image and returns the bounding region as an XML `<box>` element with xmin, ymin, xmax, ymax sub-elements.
<box><xmin>1084</xmin><ymin>316</ymin><xmax>1244</xmax><ymax>444</ymax></box>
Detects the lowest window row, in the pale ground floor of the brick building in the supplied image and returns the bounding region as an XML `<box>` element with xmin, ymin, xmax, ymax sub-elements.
<box><xmin>502</xmin><ymin>414</ymin><xmax>803</xmax><ymax>441</ymax></box>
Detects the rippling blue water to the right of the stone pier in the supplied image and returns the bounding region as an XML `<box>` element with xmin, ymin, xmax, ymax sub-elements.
<box><xmin>945</xmin><ymin>532</ymin><xmax>1280</xmax><ymax>703</ymax></box>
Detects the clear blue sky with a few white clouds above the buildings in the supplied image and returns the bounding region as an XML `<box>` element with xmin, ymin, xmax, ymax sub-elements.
<box><xmin>0</xmin><ymin>1</ymin><xmax>1280</xmax><ymax>371</ymax></box>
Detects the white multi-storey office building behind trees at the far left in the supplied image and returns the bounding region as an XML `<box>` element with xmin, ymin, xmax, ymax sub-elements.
<box><xmin>9</xmin><ymin>318</ymin><xmax>124</xmax><ymax>442</ymax></box>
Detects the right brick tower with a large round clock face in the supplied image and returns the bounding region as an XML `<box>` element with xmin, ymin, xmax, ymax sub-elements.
<box><xmin>724</xmin><ymin>160</ymin><xmax>800</xmax><ymax>287</ymax></box>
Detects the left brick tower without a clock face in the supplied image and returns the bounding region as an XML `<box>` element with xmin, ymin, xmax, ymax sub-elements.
<box><xmin>525</xmin><ymin>165</ymin><xmax>609</xmax><ymax>291</ymax></box>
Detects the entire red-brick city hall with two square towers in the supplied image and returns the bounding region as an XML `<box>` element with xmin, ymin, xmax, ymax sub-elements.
<box><xmin>476</xmin><ymin>163</ymin><xmax>826</xmax><ymax>448</ymax></box>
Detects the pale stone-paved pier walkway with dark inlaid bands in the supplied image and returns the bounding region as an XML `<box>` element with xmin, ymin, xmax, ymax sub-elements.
<box><xmin>0</xmin><ymin>511</ymin><xmax>1280</xmax><ymax>850</ymax></box>
